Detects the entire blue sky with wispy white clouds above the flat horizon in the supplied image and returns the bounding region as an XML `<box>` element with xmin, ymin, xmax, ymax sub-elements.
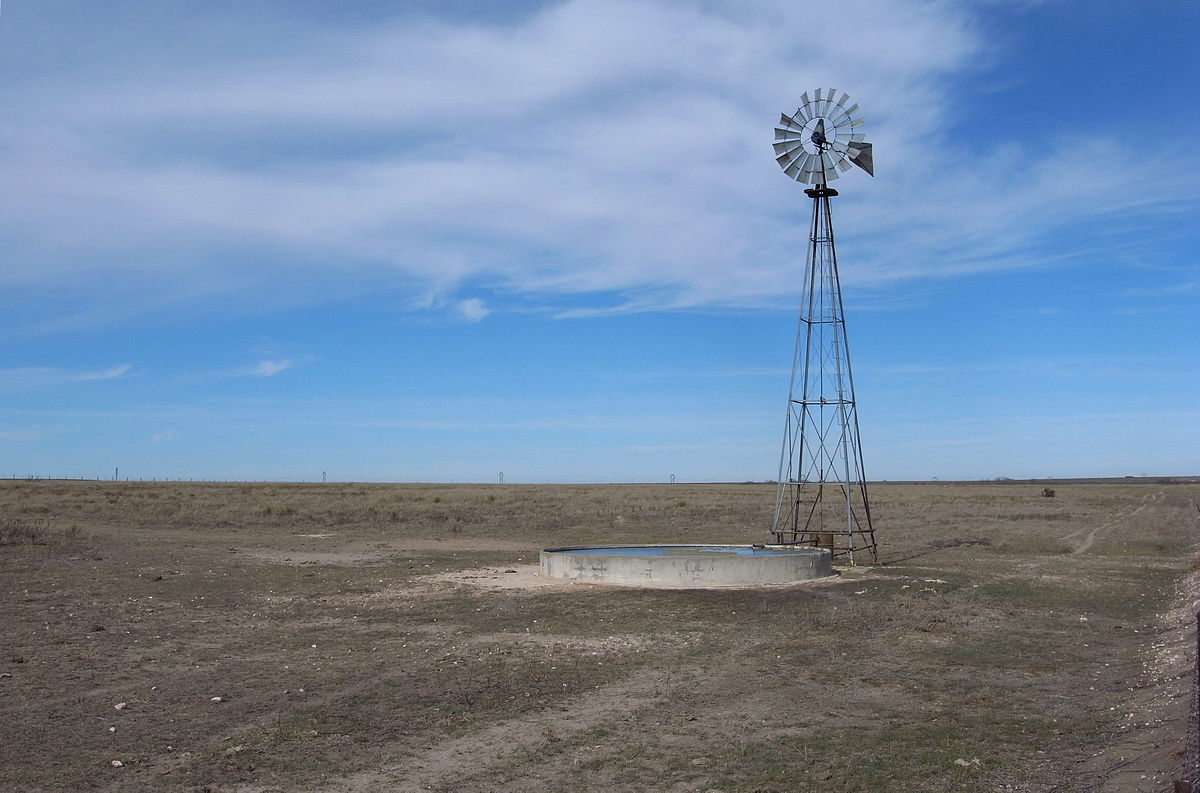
<box><xmin>0</xmin><ymin>0</ymin><xmax>1200</xmax><ymax>482</ymax></box>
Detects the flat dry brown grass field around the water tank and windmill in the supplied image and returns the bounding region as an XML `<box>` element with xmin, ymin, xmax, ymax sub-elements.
<box><xmin>0</xmin><ymin>472</ymin><xmax>1200</xmax><ymax>793</ymax></box>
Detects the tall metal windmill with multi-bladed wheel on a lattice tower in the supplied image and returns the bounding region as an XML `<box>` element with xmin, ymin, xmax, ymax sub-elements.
<box><xmin>770</xmin><ymin>88</ymin><xmax>878</xmax><ymax>564</ymax></box>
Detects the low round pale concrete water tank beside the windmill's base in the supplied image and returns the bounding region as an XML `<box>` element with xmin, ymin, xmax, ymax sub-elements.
<box><xmin>541</xmin><ymin>546</ymin><xmax>833</xmax><ymax>588</ymax></box>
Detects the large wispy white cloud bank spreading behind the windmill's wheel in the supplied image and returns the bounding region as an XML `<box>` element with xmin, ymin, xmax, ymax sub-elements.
<box><xmin>0</xmin><ymin>0</ymin><xmax>1188</xmax><ymax>328</ymax></box>
